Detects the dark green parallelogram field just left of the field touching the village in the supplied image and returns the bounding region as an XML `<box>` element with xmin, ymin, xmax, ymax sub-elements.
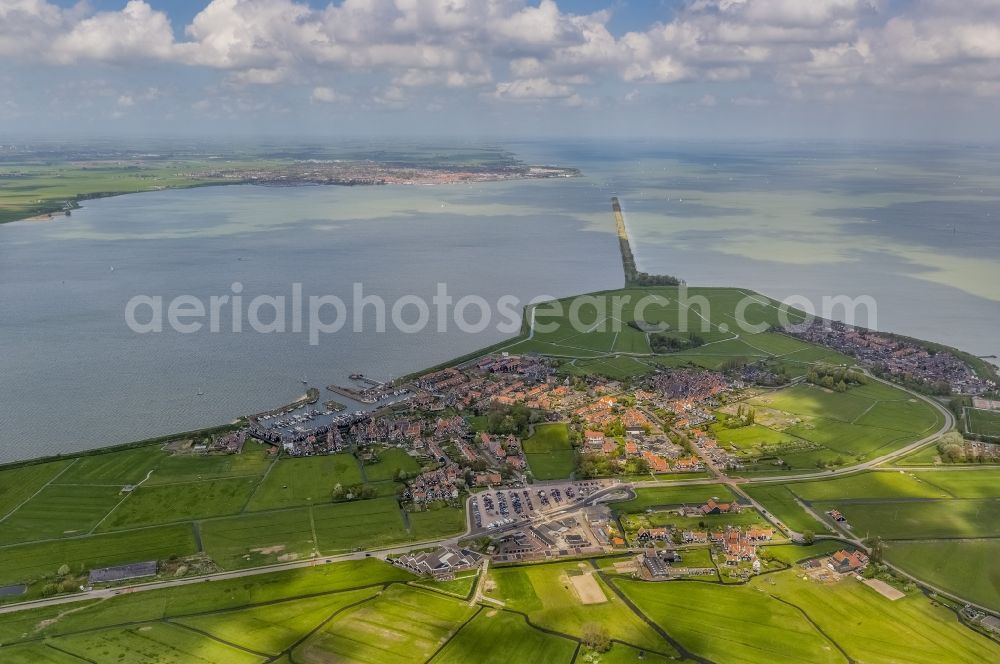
<box><xmin>100</xmin><ymin>477</ymin><xmax>257</xmax><ymax>531</ymax></box>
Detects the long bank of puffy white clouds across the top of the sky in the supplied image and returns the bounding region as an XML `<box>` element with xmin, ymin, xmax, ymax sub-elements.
<box><xmin>0</xmin><ymin>0</ymin><xmax>1000</xmax><ymax>120</ymax></box>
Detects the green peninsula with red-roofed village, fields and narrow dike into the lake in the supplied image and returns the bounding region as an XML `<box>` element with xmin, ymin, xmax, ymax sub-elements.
<box><xmin>0</xmin><ymin>195</ymin><xmax>1000</xmax><ymax>663</ymax></box>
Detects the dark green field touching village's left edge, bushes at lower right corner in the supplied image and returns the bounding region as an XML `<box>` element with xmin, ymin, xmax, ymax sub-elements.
<box><xmin>247</xmin><ymin>454</ymin><xmax>361</xmax><ymax>510</ymax></box>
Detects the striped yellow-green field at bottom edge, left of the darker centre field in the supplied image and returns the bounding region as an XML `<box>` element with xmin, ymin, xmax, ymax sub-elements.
<box><xmin>293</xmin><ymin>586</ymin><xmax>475</xmax><ymax>664</ymax></box>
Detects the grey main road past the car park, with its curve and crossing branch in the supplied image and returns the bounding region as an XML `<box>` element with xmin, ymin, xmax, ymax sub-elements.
<box><xmin>0</xmin><ymin>376</ymin><xmax>964</xmax><ymax>614</ymax></box>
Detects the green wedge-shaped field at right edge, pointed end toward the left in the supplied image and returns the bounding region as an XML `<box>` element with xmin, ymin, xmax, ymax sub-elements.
<box><xmin>886</xmin><ymin>539</ymin><xmax>1000</xmax><ymax>611</ymax></box>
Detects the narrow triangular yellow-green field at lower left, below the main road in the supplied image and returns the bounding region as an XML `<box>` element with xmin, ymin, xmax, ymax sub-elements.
<box><xmin>174</xmin><ymin>586</ymin><xmax>381</xmax><ymax>655</ymax></box>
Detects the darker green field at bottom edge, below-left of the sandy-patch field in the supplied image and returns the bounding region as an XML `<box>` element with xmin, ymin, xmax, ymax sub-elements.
<box><xmin>431</xmin><ymin>608</ymin><xmax>577</xmax><ymax>664</ymax></box>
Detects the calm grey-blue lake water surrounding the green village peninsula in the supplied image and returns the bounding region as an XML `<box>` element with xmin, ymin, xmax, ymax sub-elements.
<box><xmin>0</xmin><ymin>143</ymin><xmax>1000</xmax><ymax>460</ymax></box>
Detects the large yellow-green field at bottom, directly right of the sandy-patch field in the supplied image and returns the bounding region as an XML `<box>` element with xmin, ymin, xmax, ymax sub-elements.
<box><xmin>616</xmin><ymin>575</ymin><xmax>845</xmax><ymax>664</ymax></box>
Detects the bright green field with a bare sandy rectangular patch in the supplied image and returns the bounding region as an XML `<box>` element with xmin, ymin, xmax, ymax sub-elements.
<box><xmin>488</xmin><ymin>562</ymin><xmax>673</xmax><ymax>654</ymax></box>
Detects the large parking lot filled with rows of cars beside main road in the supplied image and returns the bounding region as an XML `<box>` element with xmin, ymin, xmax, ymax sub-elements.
<box><xmin>469</xmin><ymin>480</ymin><xmax>614</xmax><ymax>531</ymax></box>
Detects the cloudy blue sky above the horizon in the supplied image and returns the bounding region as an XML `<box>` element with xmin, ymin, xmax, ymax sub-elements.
<box><xmin>0</xmin><ymin>0</ymin><xmax>1000</xmax><ymax>141</ymax></box>
